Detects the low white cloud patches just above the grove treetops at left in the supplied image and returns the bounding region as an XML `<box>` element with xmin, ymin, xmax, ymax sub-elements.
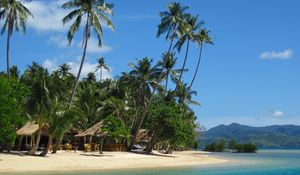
<box><xmin>42</xmin><ymin>59</ymin><xmax>112</xmax><ymax>80</ymax></box>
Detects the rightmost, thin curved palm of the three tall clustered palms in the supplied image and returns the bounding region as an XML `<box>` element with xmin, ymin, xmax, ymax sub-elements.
<box><xmin>189</xmin><ymin>29</ymin><xmax>213</xmax><ymax>88</ymax></box>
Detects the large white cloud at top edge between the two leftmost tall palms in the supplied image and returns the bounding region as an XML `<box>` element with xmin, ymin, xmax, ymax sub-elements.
<box><xmin>25</xmin><ymin>0</ymin><xmax>67</xmax><ymax>32</ymax></box>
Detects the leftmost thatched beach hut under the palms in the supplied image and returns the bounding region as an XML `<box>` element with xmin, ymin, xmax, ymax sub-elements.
<box><xmin>16</xmin><ymin>122</ymin><xmax>49</xmax><ymax>149</ymax></box>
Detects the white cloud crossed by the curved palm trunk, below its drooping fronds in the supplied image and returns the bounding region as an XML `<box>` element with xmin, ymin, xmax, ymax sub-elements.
<box><xmin>77</xmin><ymin>37</ymin><xmax>112</xmax><ymax>53</ymax></box>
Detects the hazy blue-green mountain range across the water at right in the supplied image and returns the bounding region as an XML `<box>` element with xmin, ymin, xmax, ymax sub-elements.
<box><xmin>197</xmin><ymin>123</ymin><xmax>300</xmax><ymax>148</ymax></box>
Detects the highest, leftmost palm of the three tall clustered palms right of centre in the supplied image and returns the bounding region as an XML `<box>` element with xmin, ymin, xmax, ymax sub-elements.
<box><xmin>157</xmin><ymin>2</ymin><xmax>188</xmax><ymax>52</ymax></box>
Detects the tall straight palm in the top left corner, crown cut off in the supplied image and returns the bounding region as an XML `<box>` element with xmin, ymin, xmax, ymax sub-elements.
<box><xmin>0</xmin><ymin>0</ymin><xmax>33</xmax><ymax>78</ymax></box>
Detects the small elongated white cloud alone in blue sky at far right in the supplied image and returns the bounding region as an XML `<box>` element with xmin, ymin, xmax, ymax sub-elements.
<box><xmin>259</xmin><ymin>49</ymin><xmax>294</xmax><ymax>60</ymax></box>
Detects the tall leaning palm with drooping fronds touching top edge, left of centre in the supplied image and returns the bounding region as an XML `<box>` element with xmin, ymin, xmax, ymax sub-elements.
<box><xmin>62</xmin><ymin>0</ymin><xmax>114</xmax><ymax>108</ymax></box>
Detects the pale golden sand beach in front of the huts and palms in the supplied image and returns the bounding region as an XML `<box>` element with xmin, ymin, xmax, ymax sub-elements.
<box><xmin>0</xmin><ymin>151</ymin><xmax>227</xmax><ymax>173</ymax></box>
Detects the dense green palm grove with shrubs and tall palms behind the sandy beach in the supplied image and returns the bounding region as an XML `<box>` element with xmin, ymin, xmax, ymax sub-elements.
<box><xmin>0</xmin><ymin>0</ymin><xmax>212</xmax><ymax>155</ymax></box>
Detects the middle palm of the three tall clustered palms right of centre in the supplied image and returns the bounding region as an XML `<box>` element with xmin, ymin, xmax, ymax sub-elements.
<box><xmin>175</xmin><ymin>14</ymin><xmax>203</xmax><ymax>81</ymax></box>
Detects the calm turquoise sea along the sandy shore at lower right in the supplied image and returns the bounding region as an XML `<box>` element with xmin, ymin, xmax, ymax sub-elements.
<box><xmin>8</xmin><ymin>150</ymin><xmax>300</xmax><ymax>175</ymax></box>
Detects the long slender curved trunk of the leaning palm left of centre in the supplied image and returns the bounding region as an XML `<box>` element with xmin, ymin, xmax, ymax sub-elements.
<box><xmin>68</xmin><ymin>14</ymin><xmax>89</xmax><ymax>109</ymax></box>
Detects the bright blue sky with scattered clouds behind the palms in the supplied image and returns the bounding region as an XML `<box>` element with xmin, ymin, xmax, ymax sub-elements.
<box><xmin>0</xmin><ymin>0</ymin><xmax>300</xmax><ymax>129</ymax></box>
